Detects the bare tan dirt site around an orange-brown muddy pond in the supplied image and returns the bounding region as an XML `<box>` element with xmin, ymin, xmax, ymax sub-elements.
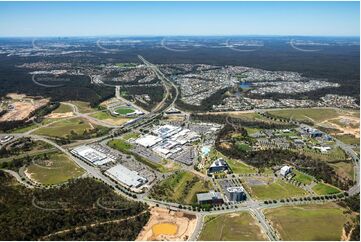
<box><xmin>136</xmin><ymin>207</ymin><xmax>197</xmax><ymax>241</ymax></box>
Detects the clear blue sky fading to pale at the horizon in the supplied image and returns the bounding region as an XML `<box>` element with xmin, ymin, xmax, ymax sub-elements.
<box><xmin>0</xmin><ymin>1</ymin><xmax>360</xmax><ymax>37</ymax></box>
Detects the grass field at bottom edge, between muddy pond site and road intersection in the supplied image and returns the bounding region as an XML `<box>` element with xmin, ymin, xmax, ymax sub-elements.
<box><xmin>198</xmin><ymin>212</ymin><xmax>267</xmax><ymax>241</ymax></box>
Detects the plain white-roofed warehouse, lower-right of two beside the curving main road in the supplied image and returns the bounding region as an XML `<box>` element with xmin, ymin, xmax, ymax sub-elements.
<box><xmin>105</xmin><ymin>164</ymin><xmax>148</xmax><ymax>188</ymax></box>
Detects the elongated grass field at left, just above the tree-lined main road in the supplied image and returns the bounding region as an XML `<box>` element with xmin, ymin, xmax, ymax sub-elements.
<box><xmin>34</xmin><ymin>118</ymin><xmax>105</xmax><ymax>138</ymax></box>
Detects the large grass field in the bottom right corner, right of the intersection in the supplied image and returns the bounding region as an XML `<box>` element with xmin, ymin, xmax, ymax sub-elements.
<box><xmin>264</xmin><ymin>203</ymin><xmax>349</xmax><ymax>241</ymax></box>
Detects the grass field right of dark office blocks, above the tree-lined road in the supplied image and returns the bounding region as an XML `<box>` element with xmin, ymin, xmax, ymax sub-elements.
<box><xmin>245</xmin><ymin>178</ymin><xmax>307</xmax><ymax>200</ymax></box>
